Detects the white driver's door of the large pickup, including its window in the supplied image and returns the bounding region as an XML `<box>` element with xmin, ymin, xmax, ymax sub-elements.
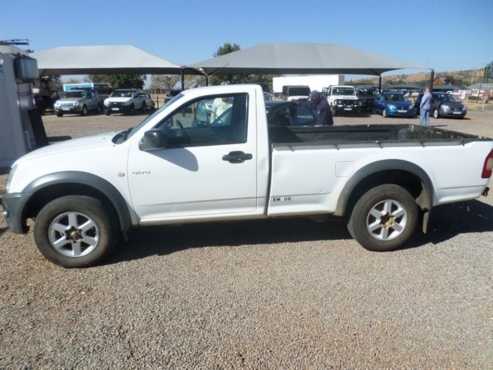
<box><xmin>128</xmin><ymin>93</ymin><xmax>262</xmax><ymax>223</ymax></box>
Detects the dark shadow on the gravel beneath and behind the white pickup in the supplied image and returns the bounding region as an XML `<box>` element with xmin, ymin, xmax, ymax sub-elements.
<box><xmin>108</xmin><ymin>201</ymin><xmax>493</xmax><ymax>264</ymax></box>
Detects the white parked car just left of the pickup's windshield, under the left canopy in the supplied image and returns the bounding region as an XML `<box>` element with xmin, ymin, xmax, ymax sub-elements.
<box><xmin>104</xmin><ymin>89</ymin><xmax>154</xmax><ymax>115</ymax></box>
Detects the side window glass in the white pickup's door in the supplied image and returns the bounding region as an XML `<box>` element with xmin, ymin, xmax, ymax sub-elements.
<box><xmin>156</xmin><ymin>94</ymin><xmax>247</xmax><ymax>147</ymax></box>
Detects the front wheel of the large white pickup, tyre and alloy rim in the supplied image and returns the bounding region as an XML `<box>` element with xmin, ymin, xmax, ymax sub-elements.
<box><xmin>34</xmin><ymin>195</ymin><xmax>118</xmax><ymax>268</ymax></box>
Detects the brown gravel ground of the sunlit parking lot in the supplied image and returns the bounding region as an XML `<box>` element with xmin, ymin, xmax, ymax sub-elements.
<box><xmin>0</xmin><ymin>112</ymin><xmax>493</xmax><ymax>369</ymax></box>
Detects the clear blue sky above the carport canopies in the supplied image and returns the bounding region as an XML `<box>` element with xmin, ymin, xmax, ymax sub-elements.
<box><xmin>0</xmin><ymin>0</ymin><xmax>493</xmax><ymax>70</ymax></box>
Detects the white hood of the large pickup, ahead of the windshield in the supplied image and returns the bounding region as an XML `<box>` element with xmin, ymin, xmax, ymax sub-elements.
<box><xmin>16</xmin><ymin>132</ymin><xmax>116</xmax><ymax>164</ymax></box>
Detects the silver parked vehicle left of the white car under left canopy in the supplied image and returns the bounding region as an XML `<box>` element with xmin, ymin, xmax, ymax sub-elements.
<box><xmin>53</xmin><ymin>90</ymin><xmax>101</xmax><ymax>117</ymax></box>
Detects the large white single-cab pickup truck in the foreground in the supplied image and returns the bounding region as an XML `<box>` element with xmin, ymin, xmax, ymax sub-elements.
<box><xmin>2</xmin><ymin>85</ymin><xmax>493</xmax><ymax>267</ymax></box>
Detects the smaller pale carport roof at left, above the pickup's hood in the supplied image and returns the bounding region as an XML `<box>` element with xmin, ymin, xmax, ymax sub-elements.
<box><xmin>32</xmin><ymin>45</ymin><xmax>182</xmax><ymax>75</ymax></box>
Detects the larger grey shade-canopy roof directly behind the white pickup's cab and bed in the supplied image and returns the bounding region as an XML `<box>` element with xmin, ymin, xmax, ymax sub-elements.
<box><xmin>194</xmin><ymin>43</ymin><xmax>422</xmax><ymax>75</ymax></box>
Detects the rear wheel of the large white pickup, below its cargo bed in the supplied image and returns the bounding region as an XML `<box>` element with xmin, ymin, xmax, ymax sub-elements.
<box><xmin>348</xmin><ymin>184</ymin><xmax>419</xmax><ymax>252</ymax></box>
